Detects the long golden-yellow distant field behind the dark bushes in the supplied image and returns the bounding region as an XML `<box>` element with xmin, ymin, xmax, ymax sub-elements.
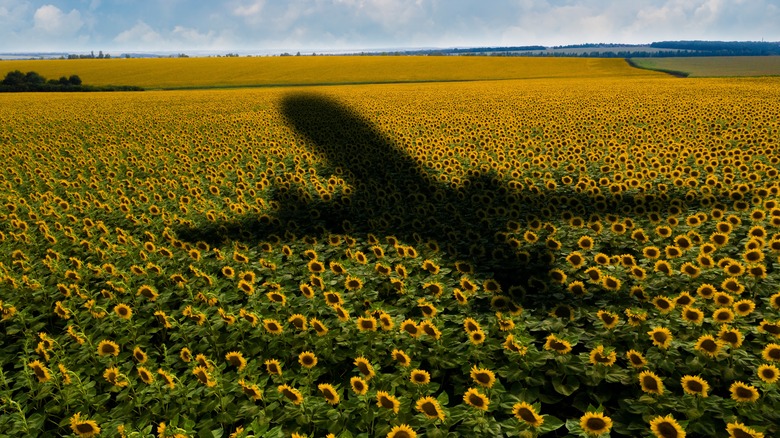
<box><xmin>0</xmin><ymin>56</ymin><xmax>656</xmax><ymax>88</ymax></box>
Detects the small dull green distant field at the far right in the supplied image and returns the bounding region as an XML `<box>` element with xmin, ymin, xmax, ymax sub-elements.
<box><xmin>633</xmin><ymin>56</ymin><xmax>780</xmax><ymax>77</ymax></box>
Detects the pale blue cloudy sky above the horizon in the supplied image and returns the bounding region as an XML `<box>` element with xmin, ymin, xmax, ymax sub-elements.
<box><xmin>0</xmin><ymin>0</ymin><xmax>780</xmax><ymax>54</ymax></box>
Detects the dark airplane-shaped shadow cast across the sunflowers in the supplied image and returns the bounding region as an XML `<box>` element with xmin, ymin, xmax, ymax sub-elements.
<box><xmin>176</xmin><ymin>93</ymin><xmax>723</xmax><ymax>305</ymax></box>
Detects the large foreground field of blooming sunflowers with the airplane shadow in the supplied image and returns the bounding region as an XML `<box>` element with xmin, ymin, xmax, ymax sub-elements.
<box><xmin>0</xmin><ymin>61</ymin><xmax>780</xmax><ymax>438</ymax></box>
